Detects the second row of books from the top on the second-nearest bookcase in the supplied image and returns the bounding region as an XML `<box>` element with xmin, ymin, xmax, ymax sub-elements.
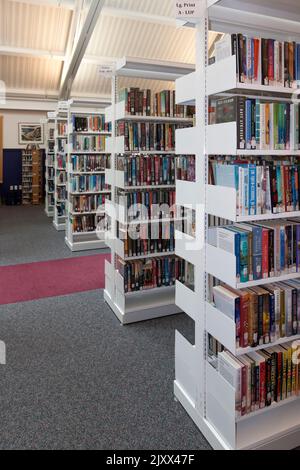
<box><xmin>117</xmin><ymin>121</ymin><xmax>189</xmax><ymax>152</ymax></box>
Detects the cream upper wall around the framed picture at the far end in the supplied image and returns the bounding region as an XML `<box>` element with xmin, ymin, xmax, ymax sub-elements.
<box><xmin>0</xmin><ymin>109</ymin><xmax>47</xmax><ymax>149</ymax></box>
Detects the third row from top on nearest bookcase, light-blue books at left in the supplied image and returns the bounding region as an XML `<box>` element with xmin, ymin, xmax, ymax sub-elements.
<box><xmin>210</xmin><ymin>157</ymin><xmax>300</xmax><ymax>216</ymax></box>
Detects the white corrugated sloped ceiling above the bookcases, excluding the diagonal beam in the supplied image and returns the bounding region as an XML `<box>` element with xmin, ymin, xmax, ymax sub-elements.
<box><xmin>0</xmin><ymin>0</ymin><xmax>220</xmax><ymax>103</ymax></box>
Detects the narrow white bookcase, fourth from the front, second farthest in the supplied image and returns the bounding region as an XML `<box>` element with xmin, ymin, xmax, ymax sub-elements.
<box><xmin>53</xmin><ymin>102</ymin><xmax>69</xmax><ymax>232</ymax></box>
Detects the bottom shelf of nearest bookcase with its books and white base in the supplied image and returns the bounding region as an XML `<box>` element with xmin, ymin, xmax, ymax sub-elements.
<box><xmin>206</xmin><ymin>343</ymin><xmax>300</xmax><ymax>449</ymax></box>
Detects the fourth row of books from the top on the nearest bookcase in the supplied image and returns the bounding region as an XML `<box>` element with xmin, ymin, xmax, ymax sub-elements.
<box><xmin>208</xmin><ymin>222</ymin><xmax>300</xmax><ymax>283</ymax></box>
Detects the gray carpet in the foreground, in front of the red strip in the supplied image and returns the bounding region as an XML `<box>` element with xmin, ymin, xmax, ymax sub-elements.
<box><xmin>0</xmin><ymin>291</ymin><xmax>209</xmax><ymax>450</ymax></box>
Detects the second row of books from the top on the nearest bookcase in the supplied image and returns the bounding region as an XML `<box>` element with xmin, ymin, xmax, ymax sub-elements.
<box><xmin>216</xmin><ymin>96</ymin><xmax>300</xmax><ymax>150</ymax></box>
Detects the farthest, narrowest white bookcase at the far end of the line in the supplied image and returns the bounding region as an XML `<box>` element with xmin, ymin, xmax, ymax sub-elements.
<box><xmin>45</xmin><ymin>113</ymin><xmax>55</xmax><ymax>217</ymax></box>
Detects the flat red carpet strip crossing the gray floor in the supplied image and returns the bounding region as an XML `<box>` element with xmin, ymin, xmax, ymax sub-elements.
<box><xmin>0</xmin><ymin>255</ymin><xmax>110</xmax><ymax>305</ymax></box>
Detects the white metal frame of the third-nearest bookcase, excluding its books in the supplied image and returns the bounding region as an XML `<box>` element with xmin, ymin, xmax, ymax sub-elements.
<box><xmin>65</xmin><ymin>106</ymin><xmax>111</xmax><ymax>251</ymax></box>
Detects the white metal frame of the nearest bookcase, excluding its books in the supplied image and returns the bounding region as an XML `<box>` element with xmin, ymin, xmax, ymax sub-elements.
<box><xmin>174</xmin><ymin>0</ymin><xmax>300</xmax><ymax>450</ymax></box>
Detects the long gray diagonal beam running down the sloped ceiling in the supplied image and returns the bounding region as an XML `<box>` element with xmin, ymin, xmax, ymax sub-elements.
<box><xmin>59</xmin><ymin>0</ymin><xmax>105</xmax><ymax>100</ymax></box>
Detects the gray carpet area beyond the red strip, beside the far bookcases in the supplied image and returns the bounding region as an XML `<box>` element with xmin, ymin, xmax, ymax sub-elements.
<box><xmin>0</xmin><ymin>206</ymin><xmax>108</xmax><ymax>266</ymax></box>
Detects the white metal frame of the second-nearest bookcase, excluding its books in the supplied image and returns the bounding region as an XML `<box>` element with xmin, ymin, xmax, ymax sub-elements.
<box><xmin>104</xmin><ymin>58</ymin><xmax>194</xmax><ymax>324</ymax></box>
